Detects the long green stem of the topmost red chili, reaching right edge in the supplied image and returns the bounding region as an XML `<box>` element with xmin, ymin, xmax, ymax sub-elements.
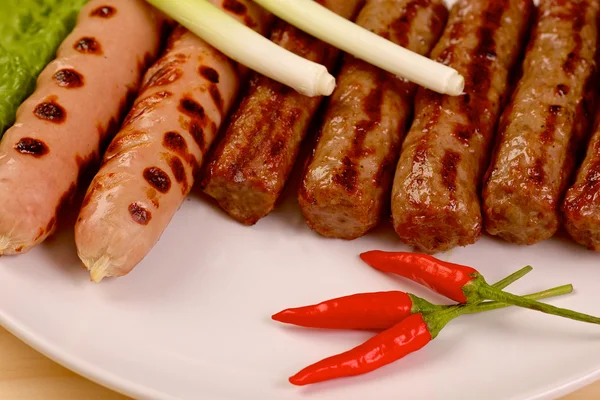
<box><xmin>463</xmin><ymin>275</ymin><xmax>600</xmax><ymax>324</ymax></box>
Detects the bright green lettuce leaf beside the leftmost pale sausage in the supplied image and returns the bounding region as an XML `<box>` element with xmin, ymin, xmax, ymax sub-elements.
<box><xmin>0</xmin><ymin>0</ymin><xmax>86</xmax><ymax>135</ymax></box>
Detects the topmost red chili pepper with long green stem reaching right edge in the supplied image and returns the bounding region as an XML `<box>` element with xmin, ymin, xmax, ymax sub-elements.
<box><xmin>360</xmin><ymin>251</ymin><xmax>600</xmax><ymax>324</ymax></box>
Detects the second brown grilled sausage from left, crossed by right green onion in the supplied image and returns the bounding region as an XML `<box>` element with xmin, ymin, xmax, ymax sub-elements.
<box><xmin>298</xmin><ymin>0</ymin><xmax>448</xmax><ymax>239</ymax></box>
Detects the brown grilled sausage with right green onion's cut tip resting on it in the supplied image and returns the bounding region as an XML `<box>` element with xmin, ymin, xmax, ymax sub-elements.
<box><xmin>392</xmin><ymin>0</ymin><xmax>534</xmax><ymax>253</ymax></box>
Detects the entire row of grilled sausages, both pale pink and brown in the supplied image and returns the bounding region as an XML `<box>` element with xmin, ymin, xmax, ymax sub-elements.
<box><xmin>0</xmin><ymin>0</ymin><xmax>600</xmax><ymax>281</ymax></box>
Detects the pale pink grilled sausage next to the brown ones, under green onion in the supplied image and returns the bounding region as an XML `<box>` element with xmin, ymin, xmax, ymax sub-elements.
<box><xmin>75</xmin><ymin>0</ymin><xmax>271</xmax><ymax>282</ymax></box>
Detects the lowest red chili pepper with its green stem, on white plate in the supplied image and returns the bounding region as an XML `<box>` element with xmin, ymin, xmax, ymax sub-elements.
<box><xmin>289</xmin><ymin>285</ymin><xmax>573</xmax><ymax>386</ymax></box>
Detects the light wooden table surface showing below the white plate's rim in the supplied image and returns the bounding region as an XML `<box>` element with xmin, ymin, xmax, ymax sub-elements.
<box><xmin>0</xmin><ymin>327</ymin><xmax>600</xmax><ymax>400</ymax></box>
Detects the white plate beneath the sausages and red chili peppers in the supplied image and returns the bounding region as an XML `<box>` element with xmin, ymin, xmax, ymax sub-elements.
<box><xmin>0</xmin><ymin>176</ymin><xmax>600</xmax><ymax>400</ymax></box>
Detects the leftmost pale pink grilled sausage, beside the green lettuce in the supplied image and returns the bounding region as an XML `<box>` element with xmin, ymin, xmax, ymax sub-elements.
<box><xmin>0</xmin><ymin>0</ymin><xmax>164</xmax><ymax>254</ymax></box>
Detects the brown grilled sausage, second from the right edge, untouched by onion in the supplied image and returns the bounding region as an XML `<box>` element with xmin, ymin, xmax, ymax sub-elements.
<box><xmin>483</xmin><ymin>0</ymin><xmax>600</xmax><ymax>244</ymax></box>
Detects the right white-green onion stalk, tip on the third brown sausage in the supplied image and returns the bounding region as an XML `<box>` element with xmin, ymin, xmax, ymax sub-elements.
<box><xmin>254</xmin><ymin>0</ymin><xmax>465</xmax><ymax>96</ymax></box>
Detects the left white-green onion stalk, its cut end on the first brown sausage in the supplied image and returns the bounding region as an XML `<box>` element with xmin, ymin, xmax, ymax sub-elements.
<box><xmin>147</xmin><ymin>0</ymin><xmax>335</xmax><ymax>96</ymax></box>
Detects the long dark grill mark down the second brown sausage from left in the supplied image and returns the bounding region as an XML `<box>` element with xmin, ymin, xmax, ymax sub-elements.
<box><xmin>332</xmin><ymin>80</ymin><xmax>385</xmax><ymax>193</ymax></box>
